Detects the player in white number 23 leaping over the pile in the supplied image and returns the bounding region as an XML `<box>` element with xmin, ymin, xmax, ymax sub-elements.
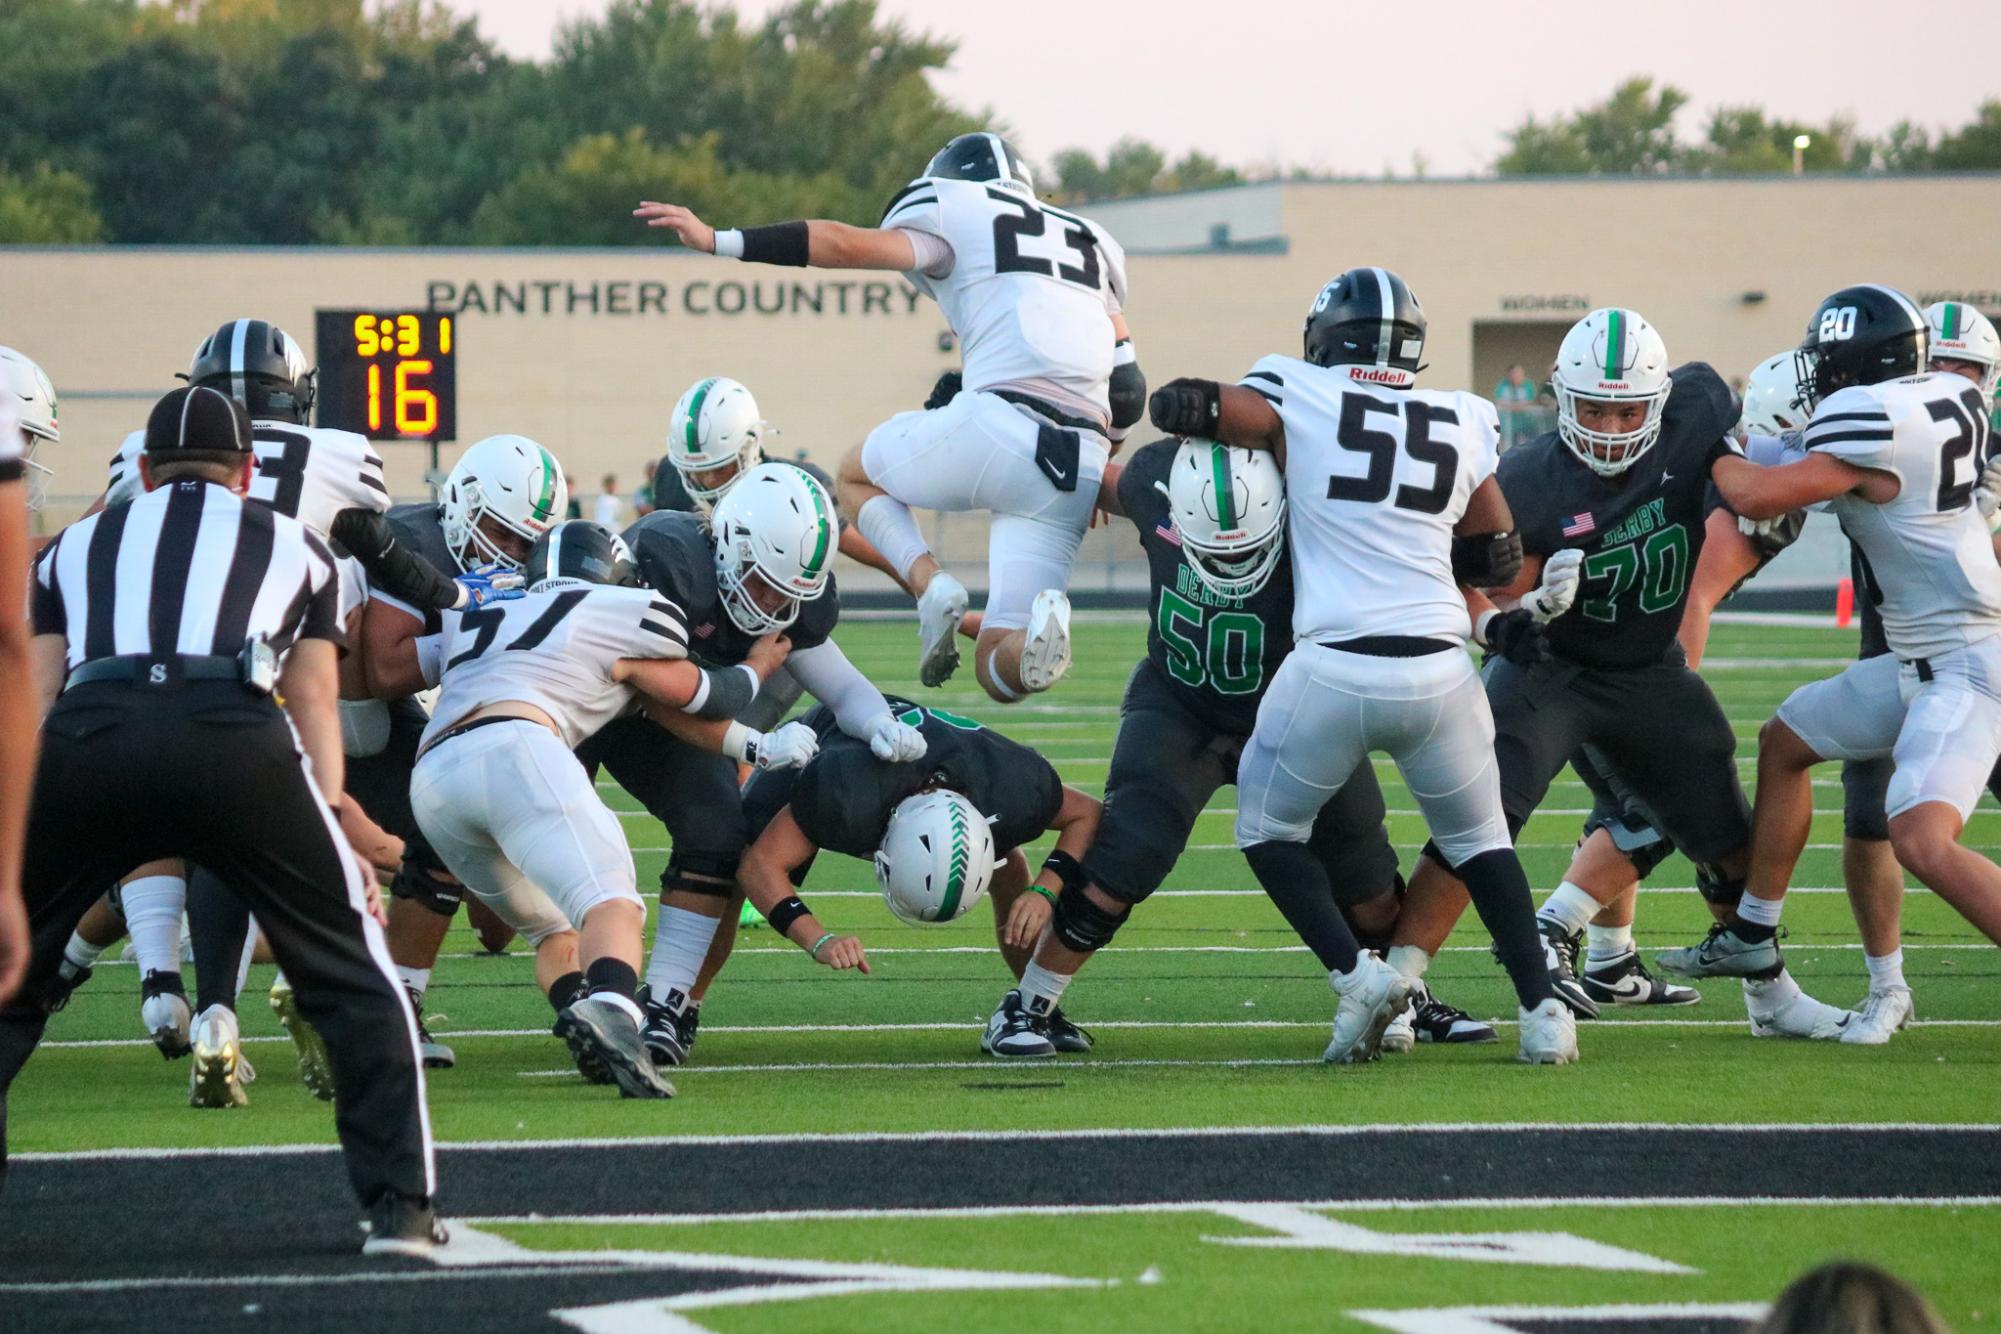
<box><xmin>634</xmin><ymin>134</ymin><xmax>1147</xmax><ymax>702</ymax></box>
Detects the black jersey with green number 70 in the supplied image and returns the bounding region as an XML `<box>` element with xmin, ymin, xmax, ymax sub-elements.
<box><xmin>1497</xmin><ymin>362</ymin><xmax>1737</xmax><ymax>670</ymax></box>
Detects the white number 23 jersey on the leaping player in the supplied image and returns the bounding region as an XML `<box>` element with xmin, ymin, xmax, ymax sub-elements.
<box><xmin>882</xmin><ymin>176</ymin><xmax>1127</xmax><ymax>424</ymax></box>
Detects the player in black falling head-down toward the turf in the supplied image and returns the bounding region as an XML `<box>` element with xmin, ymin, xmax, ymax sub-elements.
<box><xmin>712</xmin><ymin>696</ymin><xmax>1099</xmax><ymax>1052</ymax></box>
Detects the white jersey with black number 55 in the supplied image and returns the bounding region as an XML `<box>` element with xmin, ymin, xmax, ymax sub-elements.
<box><xmin>1241</xmin><ymin>356</ymin><xmax>1501</xmax><ymax>644</ymax></box>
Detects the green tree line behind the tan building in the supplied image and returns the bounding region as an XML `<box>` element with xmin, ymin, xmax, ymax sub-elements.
<box><xmin>0</xmin><ymin>0</ymin><xmax>2001</xmax><ymax>246</ymax></box>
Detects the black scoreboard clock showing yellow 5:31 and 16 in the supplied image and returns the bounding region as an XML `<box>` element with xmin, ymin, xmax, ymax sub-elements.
<box><xmin>314</xmin><ymin>310</ymin><xmax>458</xmax><ymax>442</ymax></box>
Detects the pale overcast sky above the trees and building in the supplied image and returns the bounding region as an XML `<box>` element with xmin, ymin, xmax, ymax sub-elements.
<box><xmin>448</xmin><ymin>0</ymin><xmax>2001</xmax><ymax>176</ymax></box>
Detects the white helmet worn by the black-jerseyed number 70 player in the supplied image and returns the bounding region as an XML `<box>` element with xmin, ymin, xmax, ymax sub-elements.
<box><xmin>1549</xmin><ymin>306</ymin><xmax>1675</xmax><ymax>478</ymax></box>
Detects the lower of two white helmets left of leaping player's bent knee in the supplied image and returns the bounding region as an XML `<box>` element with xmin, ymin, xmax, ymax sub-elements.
<box><xmin>708</xmin><ymin>464</ymin><xmax>840</xmax><ymax>634</ymax></box>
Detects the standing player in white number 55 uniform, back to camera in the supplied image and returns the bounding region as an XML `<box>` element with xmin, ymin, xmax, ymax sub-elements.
<box><xmin>1151</xmin><ymin>268</ymin><xmax>1577</xmax><ymax>1064</ymax></box>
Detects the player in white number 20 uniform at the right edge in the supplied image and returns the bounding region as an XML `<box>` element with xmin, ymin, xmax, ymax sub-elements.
<box><xmin>1661</xmin><ymin>284</ymin><xmax>2001</xmax><ymax>1030</ymax></box>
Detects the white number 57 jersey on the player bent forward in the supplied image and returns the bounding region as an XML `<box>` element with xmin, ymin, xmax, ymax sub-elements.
<box><xmin>418</xmin><ymin>578</ymin><xmax>688</xmax><ymax>750</ymax></box>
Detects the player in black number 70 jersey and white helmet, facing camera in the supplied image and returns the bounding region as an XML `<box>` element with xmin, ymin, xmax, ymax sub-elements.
<box><xmin>1391</xmin><ymin>308</ymin><xmax>1839</xmax><ymax>1036</ymax></box>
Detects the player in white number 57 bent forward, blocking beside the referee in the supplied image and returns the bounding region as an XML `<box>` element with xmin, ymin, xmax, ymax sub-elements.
<box><xmin>410</xmin><ymin>520</ymin><xmax>810</xmax><ymax>1098</ymax></box>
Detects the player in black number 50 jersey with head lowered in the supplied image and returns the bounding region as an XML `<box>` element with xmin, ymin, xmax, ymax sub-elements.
<box><xmin>980</xmin><ymin>440</ymin><xmax>1495</xmax><ymax>1056</ymax></box>
